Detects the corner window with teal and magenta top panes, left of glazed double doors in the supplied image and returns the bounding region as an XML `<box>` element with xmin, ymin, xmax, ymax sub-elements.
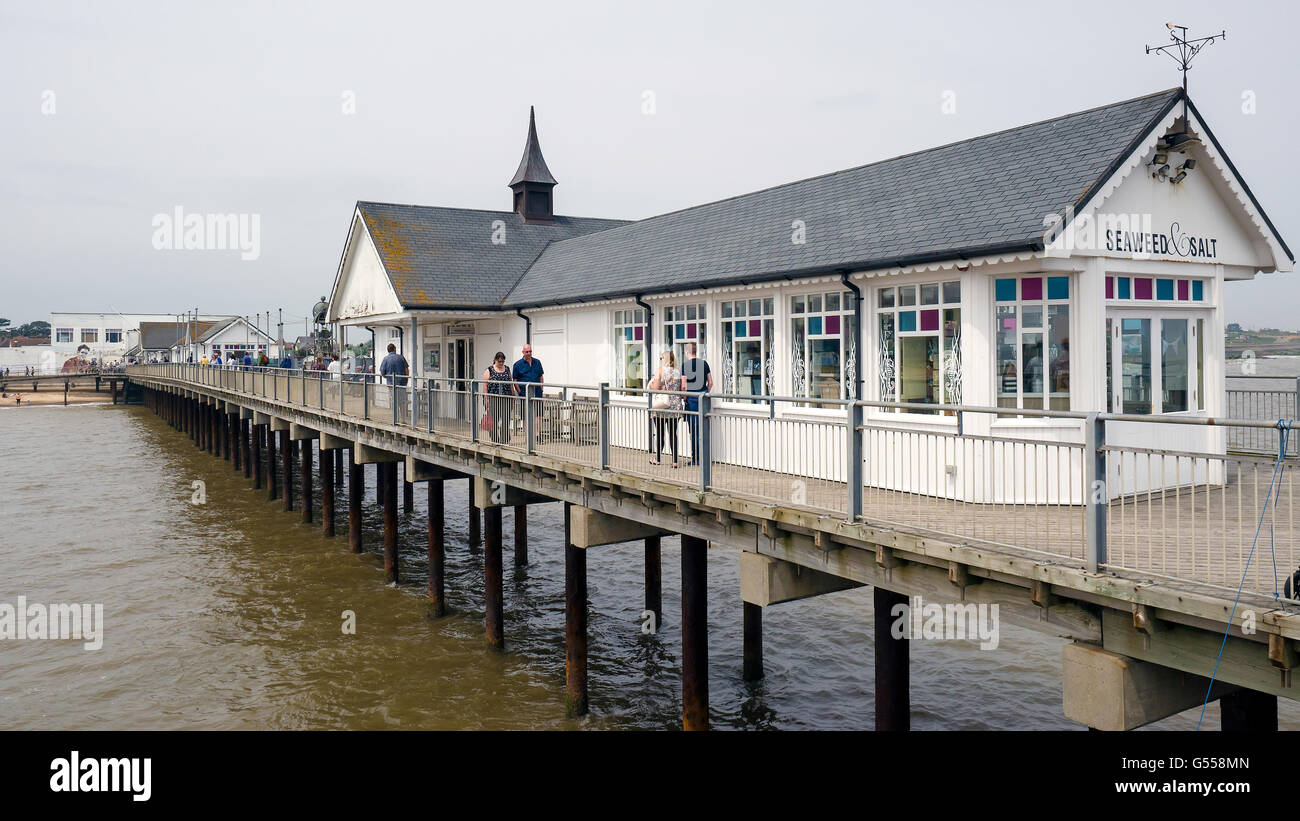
<box><xmin>993</xmin><ymin>277</ymin><xmax>1070</xmax><ymax>411</ymax></box>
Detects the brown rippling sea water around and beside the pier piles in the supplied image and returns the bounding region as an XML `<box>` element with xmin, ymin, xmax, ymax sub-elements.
<box><xmin>0</xmin><ymin>407</ymin><xmax>1300</xmax><ymax>729</ymax></box>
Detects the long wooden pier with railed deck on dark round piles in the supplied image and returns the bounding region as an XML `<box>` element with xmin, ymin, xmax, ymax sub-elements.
<box><xmin>129</xmin><ymin>364</ymin><xmax>1300</xmax><ymax>730</ymax></box>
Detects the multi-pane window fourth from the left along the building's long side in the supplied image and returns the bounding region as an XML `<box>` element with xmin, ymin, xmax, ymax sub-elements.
<box><xmin>790</xmin><ymin>291</ymin><xmax>858</xmax><ymax>399</ymax></box>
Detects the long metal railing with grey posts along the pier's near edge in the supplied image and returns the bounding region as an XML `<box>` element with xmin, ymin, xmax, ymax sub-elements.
<box><xmin>124</xmin><ymin>364</ymin><xmax>1300</xmax><ymax>596</ymax></box>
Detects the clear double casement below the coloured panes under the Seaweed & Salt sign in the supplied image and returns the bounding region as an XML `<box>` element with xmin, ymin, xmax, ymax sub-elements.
<box><xmin>1106</xmin><ymin>312</ymin><xmax>1205</xmax><ymax>414</ymax></box>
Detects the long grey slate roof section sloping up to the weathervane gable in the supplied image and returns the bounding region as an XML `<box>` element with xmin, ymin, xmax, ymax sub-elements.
<box><xmin>503</xmin><ymin>88</ymin><xmax>1182</xmax><ymax>308</ymax></box>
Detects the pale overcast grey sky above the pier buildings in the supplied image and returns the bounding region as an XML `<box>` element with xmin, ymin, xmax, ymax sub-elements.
<box><xmin>0</xmin><ymin>0</ymin><xmax>1300</xmax><ymax>334</ymax></box>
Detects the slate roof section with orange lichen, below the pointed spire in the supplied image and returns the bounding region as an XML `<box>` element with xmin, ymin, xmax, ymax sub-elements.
<box><xmin>356</xmin><ymin>201</ymin><xmax>625</xmax><ymax>308</ymax></box>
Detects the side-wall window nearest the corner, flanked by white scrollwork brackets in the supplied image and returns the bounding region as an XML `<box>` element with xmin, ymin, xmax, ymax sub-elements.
<box><xmin>876</xmin><ymin>282</ymin><xmax>962</xmax><ymax>404</ymax></box>
